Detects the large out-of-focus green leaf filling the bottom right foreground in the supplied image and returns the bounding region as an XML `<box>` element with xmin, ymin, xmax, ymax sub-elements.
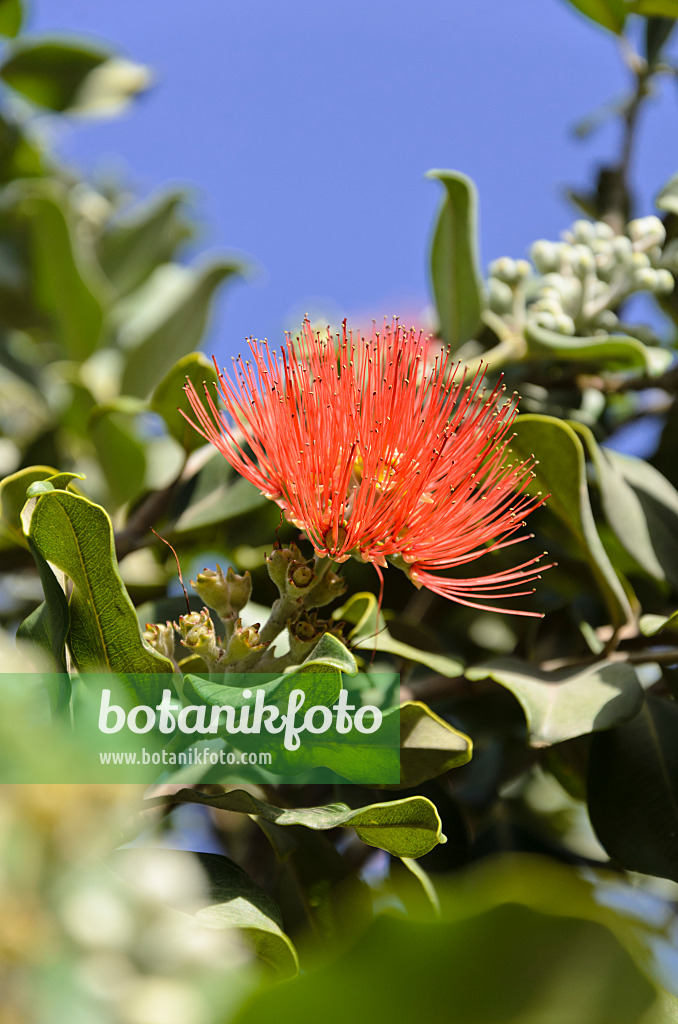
<box><xmin>232</xmin><ymin>857</ymin><xmax>660</xmax><ymax>1024</ymax></box>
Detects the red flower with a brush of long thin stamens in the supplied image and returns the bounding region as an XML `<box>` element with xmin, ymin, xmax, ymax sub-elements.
<box><xmin>185</xmin><ymin>321</ymin><xmax>544</xmax><ymax>615</ymax></box>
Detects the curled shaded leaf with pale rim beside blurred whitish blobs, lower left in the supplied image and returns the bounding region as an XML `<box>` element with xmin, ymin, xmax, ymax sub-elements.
<box><xmin>111</xmin><ymin>847</ymin><xmax>299</xmax><ymax>978</ymax></box>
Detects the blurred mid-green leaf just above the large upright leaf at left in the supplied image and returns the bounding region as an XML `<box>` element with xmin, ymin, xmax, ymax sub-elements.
<box><xmin>88</xmin><ymin>407</ymin><xmax>146</xmax><ymax>505</ymax></box>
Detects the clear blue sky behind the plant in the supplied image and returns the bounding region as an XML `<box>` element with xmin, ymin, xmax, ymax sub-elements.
<box><xmin>31</xmin><ymin>0</ymin><xmax>678</xmax><ymax>358</ymax></box>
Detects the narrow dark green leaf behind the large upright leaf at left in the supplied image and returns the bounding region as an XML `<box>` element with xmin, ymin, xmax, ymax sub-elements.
<box><xmin>16</xmin><ymin>539</ymin><xmax>71</xmax><ymax>684</ymax></box>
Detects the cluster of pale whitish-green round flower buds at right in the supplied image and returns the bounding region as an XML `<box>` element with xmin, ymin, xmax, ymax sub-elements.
<box><xmin>488</xmin><ymin>217</ymin><xmax>678</xmax><ymax>335</ymax></box>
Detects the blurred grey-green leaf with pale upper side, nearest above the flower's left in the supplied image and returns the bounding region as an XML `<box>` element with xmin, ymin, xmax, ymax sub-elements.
<box><xmin>119</xmin><ymin>260</ymin><xmax>241</xmax><ymax>397</ymax></box>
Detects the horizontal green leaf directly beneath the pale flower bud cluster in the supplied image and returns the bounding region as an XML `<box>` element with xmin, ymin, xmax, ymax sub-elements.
<box><xmin>525</xmin><ymin>321</ymin><xmax>671</xmax><ymax>375</ymax></box>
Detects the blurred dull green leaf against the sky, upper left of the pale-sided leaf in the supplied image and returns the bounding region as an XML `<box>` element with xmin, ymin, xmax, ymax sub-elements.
<box><xmin>97</xmin><ymin>189</ymin><xmax>194</xmax><ymax>295</ymax></box>
